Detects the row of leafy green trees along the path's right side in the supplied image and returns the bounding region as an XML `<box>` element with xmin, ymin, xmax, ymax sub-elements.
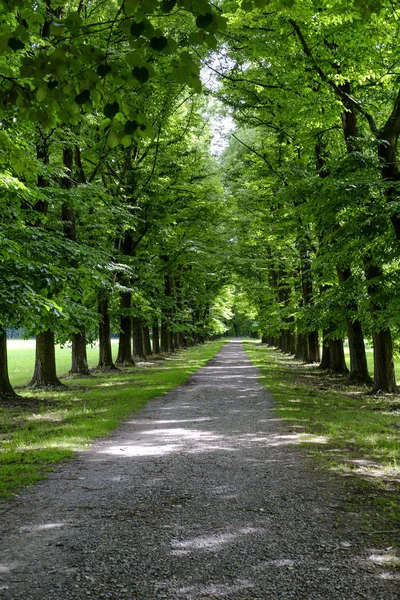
<box><xmin>214</xmin><ymin>0</ymin><xmax>400</xmax><ymax>392</ymax></box>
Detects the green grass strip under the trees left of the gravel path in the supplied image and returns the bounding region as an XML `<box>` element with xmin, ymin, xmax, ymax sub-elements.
<box><xmin>0</xmin><ymin>340</ymin><xmax>227</xmax><ymax>499</ymax></box>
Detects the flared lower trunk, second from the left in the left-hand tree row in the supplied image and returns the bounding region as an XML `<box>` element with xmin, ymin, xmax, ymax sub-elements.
<box><xmin>28</xmin><ymin>331</ymin><xmax>65</xmax><ymax>388</ymax></box>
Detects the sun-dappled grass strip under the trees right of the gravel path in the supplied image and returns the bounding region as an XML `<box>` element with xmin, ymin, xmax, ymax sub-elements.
<box><xmin>245</xmin><ymin>342</ymin><xmax>400</xmax><ymax>547</ymax></box>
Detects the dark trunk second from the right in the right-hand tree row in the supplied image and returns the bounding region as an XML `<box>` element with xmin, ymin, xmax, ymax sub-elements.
<box><xmin>337</xmin><ymin>267</ymin><xmax>372</xmax><ymax>384</ymax></box>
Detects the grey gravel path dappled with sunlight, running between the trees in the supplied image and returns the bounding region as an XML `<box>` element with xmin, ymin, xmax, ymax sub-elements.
<box><xmin>0</xmin><ymin>342</ymin><xmax>400</xmax><ymax>600</ymax></box>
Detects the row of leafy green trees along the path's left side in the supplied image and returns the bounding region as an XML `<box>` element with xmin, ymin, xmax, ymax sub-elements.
<box><xmin>0</xmin><ymin>0</ymin><xmax>238</xmax><ymax>404</ymax></box>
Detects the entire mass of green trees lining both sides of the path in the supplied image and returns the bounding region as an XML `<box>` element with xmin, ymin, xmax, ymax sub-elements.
<box><xmin>0</xmin><ymin>0</ymin><xmax>400</xmax><ymax>396</ymax></box>
